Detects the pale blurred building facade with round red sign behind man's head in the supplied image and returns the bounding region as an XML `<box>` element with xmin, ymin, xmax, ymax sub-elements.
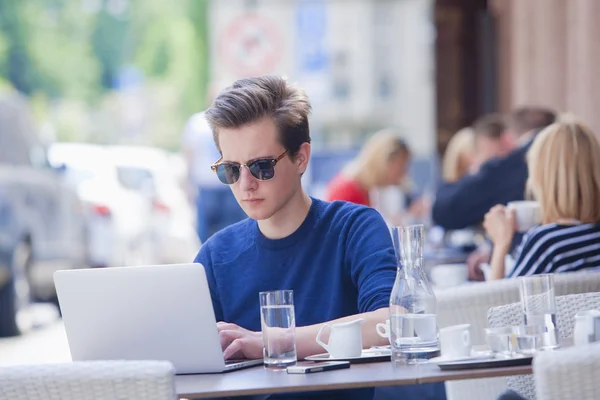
<box><xmin>209</xmin><ymin>0</ymin><xmax>436</xmax><ymax>156</ymax></box>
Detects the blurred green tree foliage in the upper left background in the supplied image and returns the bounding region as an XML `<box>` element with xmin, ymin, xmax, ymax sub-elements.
<box><xmin>0</xmin><ymin>0</ymin><xmax>209</xmax><ymax>148</ymax></box>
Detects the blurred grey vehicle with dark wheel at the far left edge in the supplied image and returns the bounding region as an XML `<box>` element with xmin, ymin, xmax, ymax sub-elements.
<box><xmin>0</xmin><ymin>93</ymin><xmax>85</xmax><ymax>336</ymax></box>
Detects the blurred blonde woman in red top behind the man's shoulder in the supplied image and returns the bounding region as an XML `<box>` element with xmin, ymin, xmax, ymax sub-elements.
<box><xmin>327</xmin><ymin>129</ymin><xmax>429</xmax><ymax>223</ymax></box>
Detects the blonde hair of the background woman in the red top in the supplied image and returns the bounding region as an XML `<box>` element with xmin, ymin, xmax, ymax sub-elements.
<box><xmin>342</xmin><ymin>129</ymin><xmax>410</xmax><ymax>190</ymax></box>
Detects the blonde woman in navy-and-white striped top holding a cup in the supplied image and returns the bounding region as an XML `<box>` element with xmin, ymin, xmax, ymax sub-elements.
<box><xmin>484</xmin><ymin>118</ymin><xmax>600</xmax><ymax>279</ymax></box>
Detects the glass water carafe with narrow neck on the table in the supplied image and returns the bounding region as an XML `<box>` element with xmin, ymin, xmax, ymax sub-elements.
<box><xmin>390</xmin><ymin>225</ymin><xmax>439</xmax><ymax>364</ymax></box>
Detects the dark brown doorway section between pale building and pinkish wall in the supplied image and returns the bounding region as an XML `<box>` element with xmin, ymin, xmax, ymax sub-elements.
<box><xmin>434</xmin><ymin>0</ymin><xmax>498</xmax><ymax>153</ymax></box>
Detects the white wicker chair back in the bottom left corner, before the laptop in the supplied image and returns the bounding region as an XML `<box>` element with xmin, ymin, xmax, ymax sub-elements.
<box><xmin>0</xmin><ymin>361</ymin><xmax>177</xmax><ymax>400</ymax></box>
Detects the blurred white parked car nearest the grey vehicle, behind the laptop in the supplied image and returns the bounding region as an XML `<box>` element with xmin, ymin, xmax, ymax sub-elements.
<box><xmin>48</xmin><ymin>143</ymin><xmax>156</xmax><ymax>267</ymax></box>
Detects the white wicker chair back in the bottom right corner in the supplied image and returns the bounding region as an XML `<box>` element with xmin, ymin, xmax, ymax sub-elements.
<box><xmin>533</xmin><ymin>343</ymin><xmax>600</xmax><ymax>400</ymax></box>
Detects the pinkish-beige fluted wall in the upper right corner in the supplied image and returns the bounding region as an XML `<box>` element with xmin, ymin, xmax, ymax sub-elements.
<box><xmin>490</xmin><ymin>0</ymin><xmax>600</xmax><ymax>132</ymax></box>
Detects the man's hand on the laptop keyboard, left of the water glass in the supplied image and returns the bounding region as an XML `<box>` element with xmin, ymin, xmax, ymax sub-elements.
<box><xmin>217</xmin><ymin>322</ymin><xmax>263</xmax><ymax>360</ymax></box>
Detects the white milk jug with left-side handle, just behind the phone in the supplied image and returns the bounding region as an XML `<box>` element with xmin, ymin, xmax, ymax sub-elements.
<box><xmin>316</xmin><ymin>318</ymin><xmax>364</xmax><ymax>358</ymax></box>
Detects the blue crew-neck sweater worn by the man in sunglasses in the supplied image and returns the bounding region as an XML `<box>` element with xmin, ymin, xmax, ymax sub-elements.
<box><xmin>195</xmin><ymin>199</ymin><xmax>396</xmax><ymax>399</ymax></box>
